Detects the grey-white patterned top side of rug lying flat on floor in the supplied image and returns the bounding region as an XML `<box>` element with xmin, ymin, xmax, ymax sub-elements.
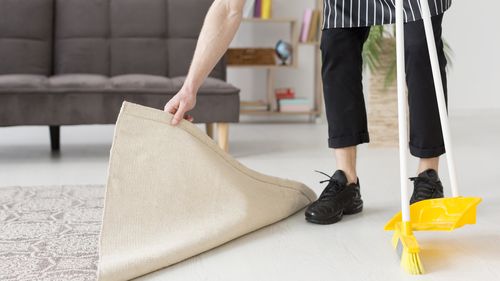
<box><xmin>0</xmin><ymin>186</ymin><xmax>104</xmax><ymax>281</ymax></box>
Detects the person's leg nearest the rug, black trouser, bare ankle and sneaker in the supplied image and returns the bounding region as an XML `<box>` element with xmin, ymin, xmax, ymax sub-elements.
<box><xmin>306</xmin><ymin>27</ymin><xmax>370</xmax><ymax>224</ymax></box>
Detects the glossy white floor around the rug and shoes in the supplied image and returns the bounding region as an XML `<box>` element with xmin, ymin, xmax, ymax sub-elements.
<box><xmin>0</xmin><ymin>113</ymin><xmax>500</xmax><ymax>281</ymax></box>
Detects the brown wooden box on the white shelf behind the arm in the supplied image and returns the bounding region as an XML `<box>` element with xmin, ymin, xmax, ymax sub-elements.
<box><xmin>227</xmin><ymin>48</ymin><xmax>276</xmax><ymax>65</ymax></box>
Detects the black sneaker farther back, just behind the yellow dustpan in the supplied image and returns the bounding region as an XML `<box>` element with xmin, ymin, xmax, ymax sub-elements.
<box><xmin>410</xmin><ymin>169</ymin><xmax>443</xmax><ymax>204</ymax></box>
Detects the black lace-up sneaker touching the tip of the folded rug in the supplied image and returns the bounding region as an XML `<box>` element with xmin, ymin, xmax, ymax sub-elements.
<box><xmin>306</xmin><ymin>170</ymin><xmax>363</xmax><ymax>224</ymax></box>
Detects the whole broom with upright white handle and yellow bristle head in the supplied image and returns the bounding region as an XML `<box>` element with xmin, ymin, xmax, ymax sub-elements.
<box><xmin>392</xmin><ymin>0</ymin><xmax>427</xmax><ymax>274</ymax></box>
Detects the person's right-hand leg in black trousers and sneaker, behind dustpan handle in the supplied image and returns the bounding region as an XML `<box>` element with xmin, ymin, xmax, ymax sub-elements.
<box><xmin>405</xmin><ymin>15</ymin><xmax>447</xmax><ymax>203</ymax></box>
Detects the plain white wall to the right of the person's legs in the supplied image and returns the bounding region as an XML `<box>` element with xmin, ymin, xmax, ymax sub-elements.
<box><xmin>443</xmin><ymin>0</ymin><xmax>500</xmax><ymax>112</ymax></box>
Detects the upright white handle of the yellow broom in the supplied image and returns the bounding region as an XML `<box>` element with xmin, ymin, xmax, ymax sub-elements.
<box><xmin>396</xmin><ymin>0</ymin><xmax>410</xmax><ymax>222</ymax></box>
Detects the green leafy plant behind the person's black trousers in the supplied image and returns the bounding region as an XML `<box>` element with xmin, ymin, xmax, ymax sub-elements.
<box><xmin>362</xmin><ymin>25</ymin><xmax>453</xmax><ymax>87</ymax></box>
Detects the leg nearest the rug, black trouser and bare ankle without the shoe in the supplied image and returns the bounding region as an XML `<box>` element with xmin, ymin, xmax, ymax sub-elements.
<box><xmin>321</xmin><ymin>27</ymin><xmax>370</xmax><ymax>183</ymax></box>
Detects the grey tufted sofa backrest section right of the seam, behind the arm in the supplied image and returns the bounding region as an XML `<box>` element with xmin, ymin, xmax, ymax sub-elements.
<box><xmin>54</xmin><ymin>0</ymin><xmax>226</xmax><ymax>80</ymax></box>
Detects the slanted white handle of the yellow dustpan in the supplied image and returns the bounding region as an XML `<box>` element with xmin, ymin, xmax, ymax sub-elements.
<box><xmin>420</xmin><ymin>0</ymin><xmax>459</xmax><ymax>197</ymax></box>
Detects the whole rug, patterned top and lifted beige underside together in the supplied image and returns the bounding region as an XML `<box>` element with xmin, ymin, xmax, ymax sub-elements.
<box><xmin>0</xmin><ymin>101</ymin><xmax>316</xmax><ymax>281</ymax></box>
